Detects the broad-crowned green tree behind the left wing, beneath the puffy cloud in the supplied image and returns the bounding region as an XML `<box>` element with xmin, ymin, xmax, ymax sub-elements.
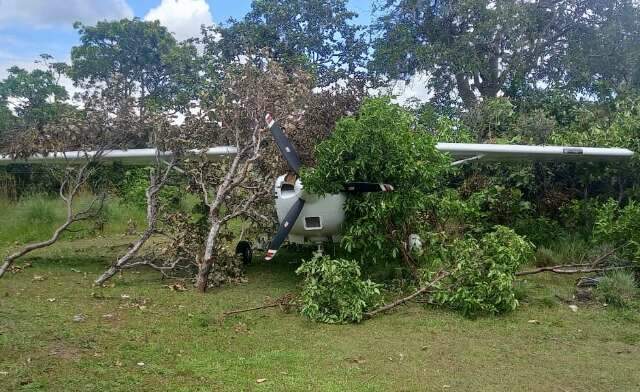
<box><xmin>69</xmin><ymin>19</ymin><xmax>200</xmax><ymax>144</ymax></box>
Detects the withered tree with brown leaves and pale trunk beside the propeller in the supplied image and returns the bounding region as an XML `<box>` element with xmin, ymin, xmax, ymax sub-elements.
<box><xmin>179</xmin><ymin>61</ymin><xmax>311</xmax><ymax>292</ymax></box>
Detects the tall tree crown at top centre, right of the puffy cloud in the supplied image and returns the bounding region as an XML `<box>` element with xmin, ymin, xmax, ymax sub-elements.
<box><xmin>216</xmin><ymin>0</ymin><xmax>368</xmax><ymax>86</ymax></box>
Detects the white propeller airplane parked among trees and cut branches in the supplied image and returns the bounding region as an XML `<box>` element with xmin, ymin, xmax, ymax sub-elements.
<box><xmin>0</xmin><ymin>114</ymin><xmax>634</xmax><ymax>260</ymax></box>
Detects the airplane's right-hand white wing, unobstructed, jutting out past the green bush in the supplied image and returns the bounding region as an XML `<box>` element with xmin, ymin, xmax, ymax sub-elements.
<box><xmin>436</xmin><ymin>143</ymin><xmax>633</xmax><ymax>165</ymax></box>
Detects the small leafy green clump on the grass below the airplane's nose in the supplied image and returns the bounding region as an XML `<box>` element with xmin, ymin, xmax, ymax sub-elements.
<box><xmin>296</xmin><ymin>256</ymin><xmax>380</xmax><ymax>324</ymax></box>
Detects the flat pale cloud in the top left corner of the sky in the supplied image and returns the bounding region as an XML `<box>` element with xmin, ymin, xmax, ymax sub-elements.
<box><xmin>0</xmin><ymin>0</ymin><xmax>133</xmax><ymax>28</ymax></box>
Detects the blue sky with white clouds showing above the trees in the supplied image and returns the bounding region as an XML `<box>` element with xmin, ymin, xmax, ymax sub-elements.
<box><xmin>0</xmin><ymin>0</ymin><xmax>426</xmax><ymax>103</ymax></box>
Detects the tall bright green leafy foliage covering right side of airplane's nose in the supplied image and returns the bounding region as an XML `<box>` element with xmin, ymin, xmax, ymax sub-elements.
<box><xmin>302</xmin><ymin>98</ymin><xmax>448</xmax><ymax>261</ymax></box>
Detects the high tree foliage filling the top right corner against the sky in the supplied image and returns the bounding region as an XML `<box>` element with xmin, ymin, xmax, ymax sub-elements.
<box><xmin>370</xmin><ymin>0</ymin><xmax>640</xmax><ymax>109</ymax></box>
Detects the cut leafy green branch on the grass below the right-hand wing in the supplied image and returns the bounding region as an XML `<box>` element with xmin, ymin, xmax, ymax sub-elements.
<box><xmin>433</xmin><ymin>226</ymin><xmax>533</xmax><ymax>316</ymax></box>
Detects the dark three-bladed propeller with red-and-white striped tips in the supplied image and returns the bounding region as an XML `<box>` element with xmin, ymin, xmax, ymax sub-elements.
<box><xmin>264</xmin><ymin>114</ymin><xmax>393</xmax><ymax>260</ymax></box>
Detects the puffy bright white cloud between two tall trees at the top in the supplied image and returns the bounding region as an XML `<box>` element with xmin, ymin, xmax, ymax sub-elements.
<box><xmin>144</xmin><ymin>0</ymin><xmax>213</xmax><ymax>40</ymax></box>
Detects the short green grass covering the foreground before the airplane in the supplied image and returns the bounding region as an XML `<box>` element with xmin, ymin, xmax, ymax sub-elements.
<box><xmin>0</xmin><ymin>236</ymin><xmax>640</xmax><ymax>391</ymax></box>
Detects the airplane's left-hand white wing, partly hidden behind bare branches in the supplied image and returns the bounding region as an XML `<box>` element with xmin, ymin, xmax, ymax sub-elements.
<box><xmin>0</xmin><ymin>146</ymin><xmax>236</xmax><ymax>166</ymax></box>
